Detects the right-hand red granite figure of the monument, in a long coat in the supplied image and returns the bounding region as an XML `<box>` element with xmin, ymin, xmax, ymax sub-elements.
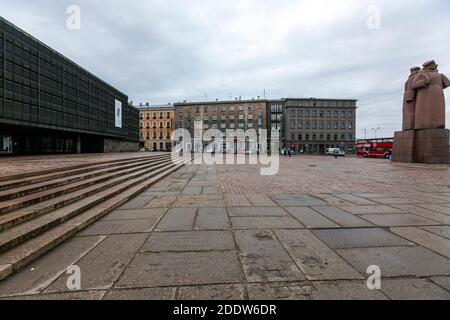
<box><xmin>413</xmin><ymin>60</ymin><xmax>450</xmax><ymax>129</ymax></box>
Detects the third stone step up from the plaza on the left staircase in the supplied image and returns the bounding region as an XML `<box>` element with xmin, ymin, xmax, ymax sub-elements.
<box><xmin>0</xmin><ymin>161</ymin><xmax>179</xmax><ymax>232</ymax></box>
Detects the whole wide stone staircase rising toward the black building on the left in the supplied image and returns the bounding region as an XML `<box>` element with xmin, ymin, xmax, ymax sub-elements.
<box><xmin>0</xmin><ymin>154</ymin><xmax>191</xmax><ymax>280</ymax></box>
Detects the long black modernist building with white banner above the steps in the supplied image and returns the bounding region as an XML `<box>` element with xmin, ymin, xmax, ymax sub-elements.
<box><xmin>0</xmin><ymin>17</ymin><xmax>139</xmax><ymax>154</ymax></box>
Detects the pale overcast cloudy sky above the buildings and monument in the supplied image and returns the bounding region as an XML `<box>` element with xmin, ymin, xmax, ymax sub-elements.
<box><xmin>0</xmin><ymin>0</ymin><xmax>450</xmax><ymax>137</ymax></box>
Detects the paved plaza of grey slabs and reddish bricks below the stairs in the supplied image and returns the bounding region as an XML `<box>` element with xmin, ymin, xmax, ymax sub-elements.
<box><xmin>0</xmin><ymin>157</ymin><xmax>450</xmax><ymax>300</ymax></box>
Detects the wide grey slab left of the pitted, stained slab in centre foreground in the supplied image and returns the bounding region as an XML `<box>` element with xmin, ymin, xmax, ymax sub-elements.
<box><xmin>141</xmin><ymin>231</ymin><xmax>234</xmax><ymax>253</ymax></box>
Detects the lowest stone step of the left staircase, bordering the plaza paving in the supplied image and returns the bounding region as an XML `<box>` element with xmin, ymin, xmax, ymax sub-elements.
<box><xmin>0</xmin><ymin>162</ymin><xmax>188</xmax><ymax>280</ymax></box>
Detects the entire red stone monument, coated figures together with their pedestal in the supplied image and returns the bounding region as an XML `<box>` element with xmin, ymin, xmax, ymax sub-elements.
<box><xmin>392</xmin><ymin>60</ymin><xmax>450</xmax><ymax>164</ymax></box>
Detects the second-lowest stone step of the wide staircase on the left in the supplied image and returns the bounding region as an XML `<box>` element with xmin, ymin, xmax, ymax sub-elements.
<box><xmin>0</xmin><ymin>155</ymin><xmax>190</xmax><ymax>253</ymax></box>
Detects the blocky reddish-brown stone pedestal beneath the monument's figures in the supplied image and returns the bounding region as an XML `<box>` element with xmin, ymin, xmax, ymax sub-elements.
<box><xmin>392</xmin><ymin>129</ymin><xmax>450</xmax><ymax>164</ymax></box>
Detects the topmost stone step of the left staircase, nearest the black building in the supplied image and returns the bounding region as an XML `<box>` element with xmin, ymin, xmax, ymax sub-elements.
<box><xmin>0</xmin><ymin>155</ymin><xmax>169</xmax><ymax>191</ymax></box>
